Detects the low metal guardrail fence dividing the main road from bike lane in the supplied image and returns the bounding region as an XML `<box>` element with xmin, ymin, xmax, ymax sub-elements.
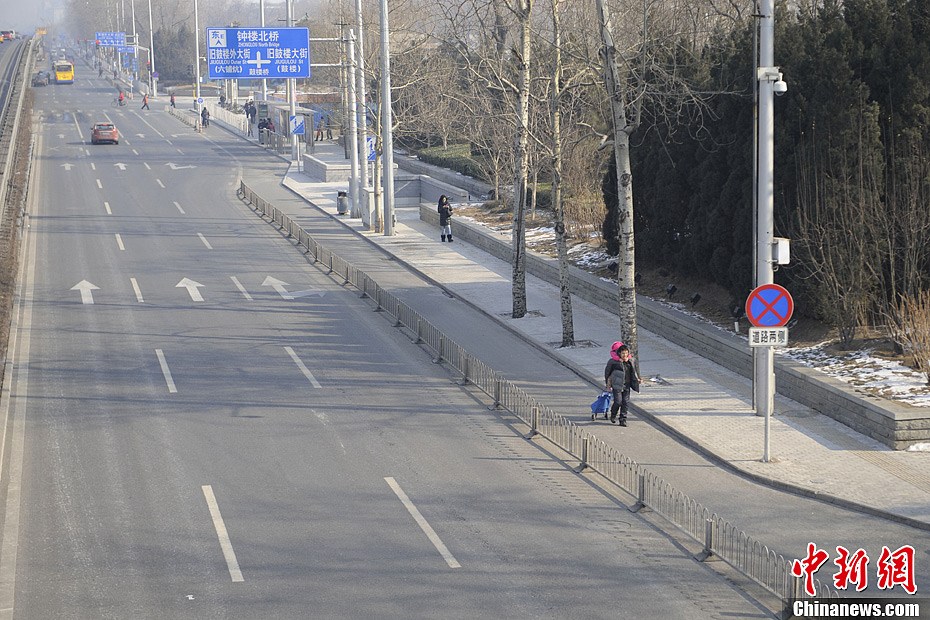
<box><xmin>238</xmin><ymin>180</ymin><xmax>839</xmax><ymax>600</ymax></box>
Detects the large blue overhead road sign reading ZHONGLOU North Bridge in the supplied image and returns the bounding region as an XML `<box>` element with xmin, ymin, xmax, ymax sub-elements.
<box><xmin>207</xmin><ymin>28</ymin><xmax>310</xmax><ymax>80</ymax></box>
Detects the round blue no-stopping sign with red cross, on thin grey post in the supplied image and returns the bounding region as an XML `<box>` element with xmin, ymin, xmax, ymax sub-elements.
<box><xmin>746</xmin><ymin>284</ymin><xmax>794</xmax><ymax>463</ymax></box>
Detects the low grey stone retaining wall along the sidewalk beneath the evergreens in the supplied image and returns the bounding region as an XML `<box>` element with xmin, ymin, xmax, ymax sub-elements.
<box><xmin>420</xmin><ymin>205</ymin><xmax>930</xmax><ymax>450</ymax></box>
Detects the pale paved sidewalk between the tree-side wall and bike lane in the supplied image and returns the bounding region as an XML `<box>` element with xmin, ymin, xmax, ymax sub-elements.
<box><xmin>236</xmin><ymin>136</ymin><xmax>930</xmax><ymax>530</ymax></box>
